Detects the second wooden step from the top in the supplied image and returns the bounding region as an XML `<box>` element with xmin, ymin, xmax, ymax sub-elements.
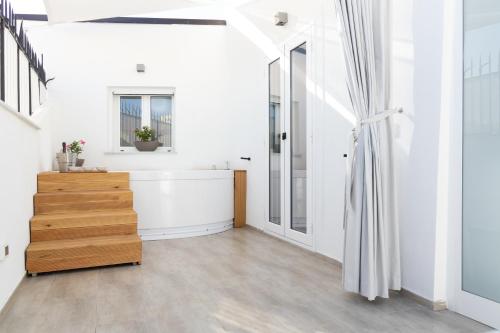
<box><xmin>34</xmin><ymin>190</ymin><xmax>133</xmax><ymax>215</ymax></box>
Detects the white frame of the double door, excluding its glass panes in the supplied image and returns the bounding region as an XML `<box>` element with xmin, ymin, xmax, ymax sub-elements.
<box><xmin>264</xmin><ymin>25</ymin><xmax>315</xmax><ymax>249</ymax></box>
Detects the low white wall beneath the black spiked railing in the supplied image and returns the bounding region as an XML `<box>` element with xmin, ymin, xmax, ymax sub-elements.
<box><xmin>0</xmin><ymin>102</ymin><xmax>50</xmax><ymax>310</ymax></box>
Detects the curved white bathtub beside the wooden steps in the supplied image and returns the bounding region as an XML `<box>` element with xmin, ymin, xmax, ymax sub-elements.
<box><xmin>129</xmin><ymin>170</ymin><xmax>234</xmax><ymax>240</ymax></box>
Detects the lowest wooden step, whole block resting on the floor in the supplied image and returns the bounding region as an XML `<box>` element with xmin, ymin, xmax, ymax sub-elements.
<box><xmin>26</xmin><ymin>235</ymin><xmax>142</xmax><ymax>273</ymax></box>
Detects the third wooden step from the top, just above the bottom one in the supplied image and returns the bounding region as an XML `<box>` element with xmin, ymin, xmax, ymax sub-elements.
<box><xmin>31</xmin><ymin>209</ymin><xmax>137</xmax><ymax>242</ymax></box>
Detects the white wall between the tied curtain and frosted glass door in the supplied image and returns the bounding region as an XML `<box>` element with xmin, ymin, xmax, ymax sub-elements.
<box><xmin>391</xmin><ymin>0</ymin><xmax>461</xmax><ymax>301</ymax></box>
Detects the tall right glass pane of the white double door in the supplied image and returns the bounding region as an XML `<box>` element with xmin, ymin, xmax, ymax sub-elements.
<box><xmin>290</xmin><ymin>43</ymin><xmax>307</xmax><ymax>234</ymax></box>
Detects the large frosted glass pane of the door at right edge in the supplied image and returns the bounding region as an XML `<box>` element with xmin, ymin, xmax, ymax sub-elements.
<box><xmin>462</xmin><ymin>0</ymin><xmax>500</xmax><ymax>302</ymax></box>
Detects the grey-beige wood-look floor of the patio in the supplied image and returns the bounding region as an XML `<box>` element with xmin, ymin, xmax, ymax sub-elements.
<box><xmin>0</xmin><ymin>229</ymin><xmax>491</xmax><ymax>333</ymax></box>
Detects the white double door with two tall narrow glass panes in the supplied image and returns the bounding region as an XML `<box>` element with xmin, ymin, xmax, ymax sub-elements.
<box><xmin>266</xmin><ymin>29</ymin><xmax>313</xmax><ymax>247</ymax></box>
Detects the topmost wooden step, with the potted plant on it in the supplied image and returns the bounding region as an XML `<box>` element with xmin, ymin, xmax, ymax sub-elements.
<box><xmin>38</xmin><ymin>172</ymin><xmax>129</xmax><ymax>193</ymax></box>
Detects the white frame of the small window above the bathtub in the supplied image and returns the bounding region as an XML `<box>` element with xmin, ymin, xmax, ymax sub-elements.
<box><xmin>108</xmin><ymin>87</ymin><xmax>176</xmax><ymax>153</ymax></box>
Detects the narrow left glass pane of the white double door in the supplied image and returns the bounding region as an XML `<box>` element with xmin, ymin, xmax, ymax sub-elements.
<box><xmin>269</xmin><ymin>59</ymin><xmax>281</xmax><ymax>225</ymax></box>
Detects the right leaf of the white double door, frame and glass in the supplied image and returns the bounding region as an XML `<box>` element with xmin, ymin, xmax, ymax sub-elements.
<box><xmin>284</xmin><ymin>33</ymin><xmax>312</xmax><ymax>246</ymax></box>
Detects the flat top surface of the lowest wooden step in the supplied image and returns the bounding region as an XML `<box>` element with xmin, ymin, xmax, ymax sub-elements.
<box><xmin>26</xmin><ymin>235</ymin><xmax>142</xmax><ymax>255</ymax></box>
